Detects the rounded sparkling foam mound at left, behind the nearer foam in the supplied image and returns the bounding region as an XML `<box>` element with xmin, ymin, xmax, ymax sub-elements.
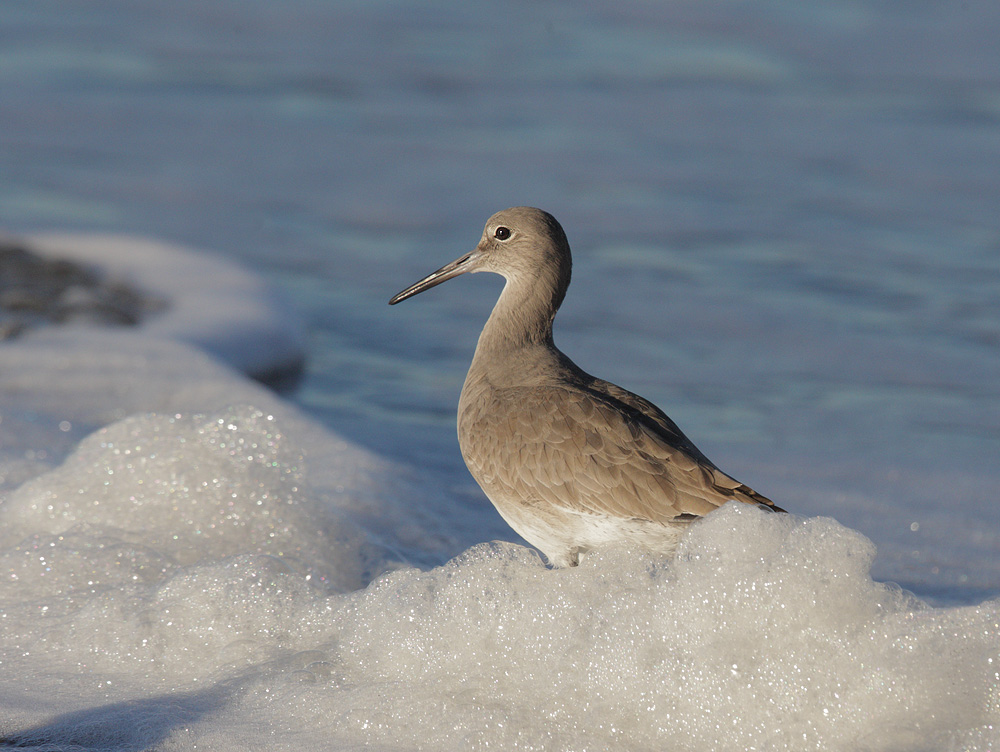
<box><xmin>0</xmin><ymin>408</ymin><xmax>382</xmax><ymax>595</ymax></box>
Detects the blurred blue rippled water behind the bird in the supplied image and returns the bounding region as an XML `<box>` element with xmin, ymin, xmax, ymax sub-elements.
<box><xmin>0</xmin><ymin>0</ymin><xmax>1000</xmax><ymax>600</ymax></box>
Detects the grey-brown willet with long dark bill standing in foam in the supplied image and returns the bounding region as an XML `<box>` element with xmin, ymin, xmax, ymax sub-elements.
<box><xmin>389</xmin><ymin>206</ymin><xmax>784</xmax><ymax>567</ymax></box>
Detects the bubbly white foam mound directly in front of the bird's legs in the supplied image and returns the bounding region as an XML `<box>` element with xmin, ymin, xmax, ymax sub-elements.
<box><xmin>316</xmin><ymin>505</ymin><xmax>1000</xmax><ymax>750</ymax></box>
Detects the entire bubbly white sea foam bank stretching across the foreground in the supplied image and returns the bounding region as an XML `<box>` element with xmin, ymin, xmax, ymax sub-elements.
<box><xmin>0</xmin><ymin>408</ymin><xmax>1000</xmax><ymax>750</ymax></box>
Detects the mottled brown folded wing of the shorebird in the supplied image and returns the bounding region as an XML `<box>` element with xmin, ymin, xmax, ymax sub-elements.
<box><xmin>463</xmin><ymin>387</ymin><xmax>776</xmax><ymax>522</ymax></box>
